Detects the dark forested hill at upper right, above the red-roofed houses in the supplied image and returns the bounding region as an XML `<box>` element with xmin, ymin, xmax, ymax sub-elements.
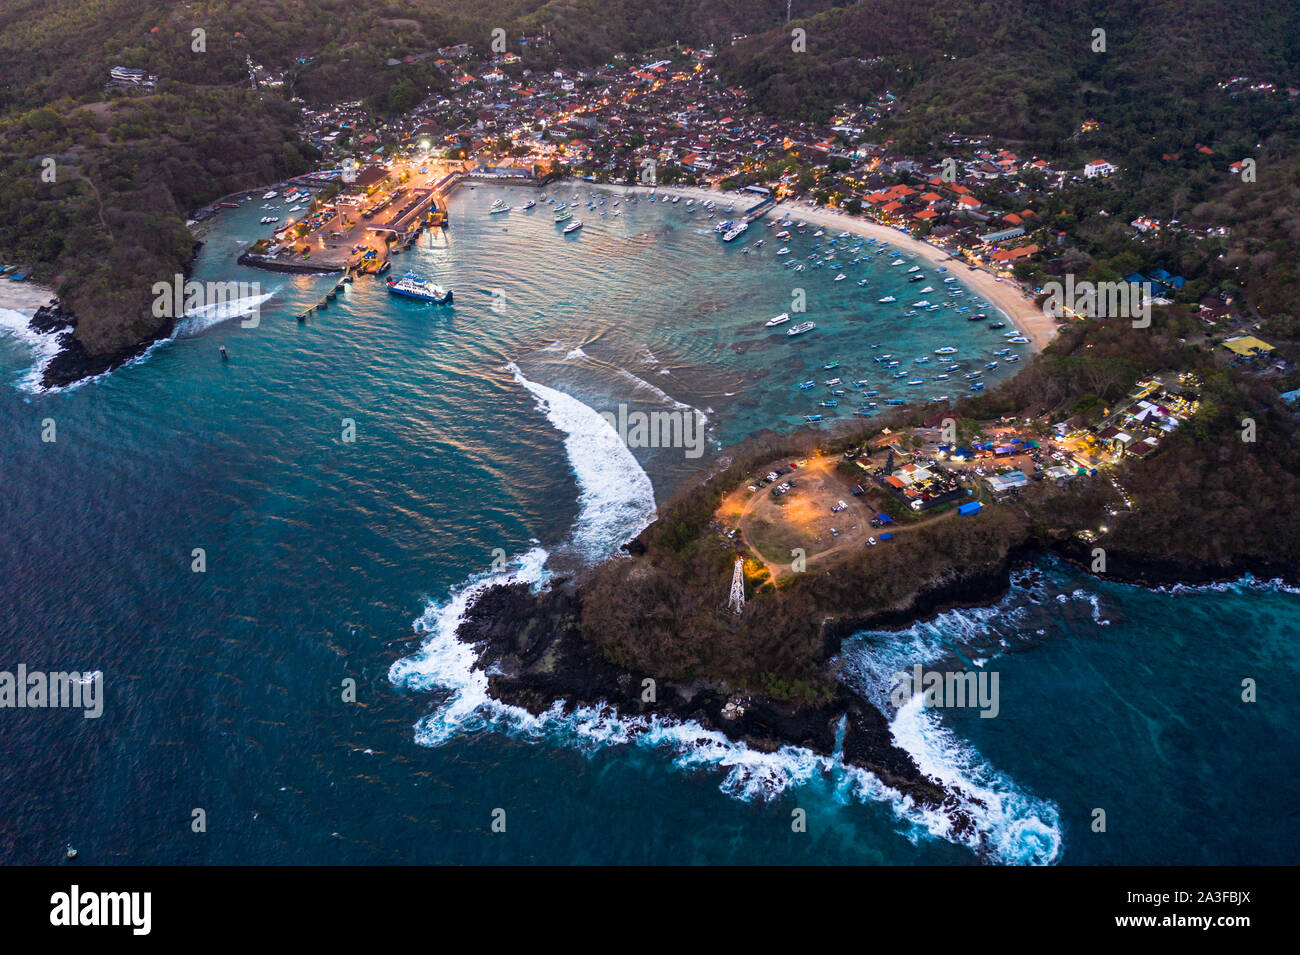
<box><xmin>719</xmin><ymin>0</ymin><xmax>1300</xmax><ymax>149</ymax></box>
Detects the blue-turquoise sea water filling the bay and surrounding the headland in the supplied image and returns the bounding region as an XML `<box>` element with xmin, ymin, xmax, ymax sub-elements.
<box><xmin>0</xmin><ymin>186</ymin><xmax>1300</xmax><ymax>865</ymax></box>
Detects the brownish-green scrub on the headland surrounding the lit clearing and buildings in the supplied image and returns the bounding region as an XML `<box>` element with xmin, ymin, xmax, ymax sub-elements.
<box><xmin>582</xmin><ymin>312</ymin><xmax>1300</xmax><ymax>699</ymax></box>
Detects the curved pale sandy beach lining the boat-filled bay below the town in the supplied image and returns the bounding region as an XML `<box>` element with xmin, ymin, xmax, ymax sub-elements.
<box><xmin>613</xmin><ymin>186</ymin><xmax>1057</xmax><ymax>352</ymax></box>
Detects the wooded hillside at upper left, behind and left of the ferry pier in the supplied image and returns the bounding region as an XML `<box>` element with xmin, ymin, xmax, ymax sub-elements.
<box><xmin>0</xmin><ymin>0</ymin><xmax>527</xmax><ymax>355</ymax></box>
